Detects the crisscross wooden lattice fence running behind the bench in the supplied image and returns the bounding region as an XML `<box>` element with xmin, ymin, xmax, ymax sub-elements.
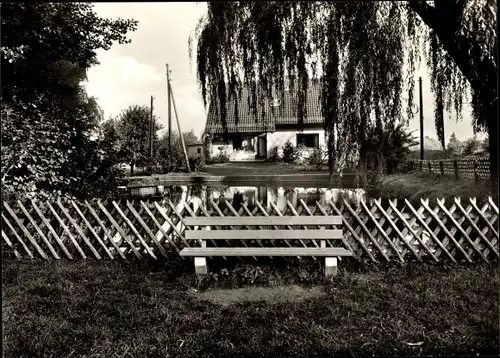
<box><xmin>1</xmin><ymin>198</ymin><xmax>499</xmax><ymax>263</ymax></box>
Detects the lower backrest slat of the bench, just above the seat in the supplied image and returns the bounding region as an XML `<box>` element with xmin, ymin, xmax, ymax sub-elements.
<box><xmin>186</xmin><ymin>229</ymin><xmax>342</xmax><ymax>240</ymax></box>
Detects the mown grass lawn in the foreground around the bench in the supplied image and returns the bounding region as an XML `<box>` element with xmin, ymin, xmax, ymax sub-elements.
<box><xmin>2</xmin><ymin>259</ymin><xmax>499</xmax><ymax>357</ymax></box>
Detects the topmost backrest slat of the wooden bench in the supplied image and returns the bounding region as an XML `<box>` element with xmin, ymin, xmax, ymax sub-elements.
<box><xmin>184</xmin><ymin>215</ymin><xmax>342</xmax><ymax>226</ymax></box>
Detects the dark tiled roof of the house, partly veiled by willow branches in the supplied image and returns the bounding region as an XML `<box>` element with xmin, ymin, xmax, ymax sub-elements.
<box><xmin>205</xmin><ymin>83</ymin><xmax>324</xmax><ymax>134</ymax></box>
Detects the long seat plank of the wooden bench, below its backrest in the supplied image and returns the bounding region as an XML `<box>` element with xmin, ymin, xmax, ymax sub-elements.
<box><xmin>180</xmin><ymin>247</ymin><xmax>353</xmax><ymax>257</ymax></box>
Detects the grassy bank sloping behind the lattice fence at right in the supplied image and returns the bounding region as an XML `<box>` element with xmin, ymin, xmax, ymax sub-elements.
<box><xmin>368</xmin><ymin>172</ymin><xmax>491</xmax><ymax>204</ymax></box>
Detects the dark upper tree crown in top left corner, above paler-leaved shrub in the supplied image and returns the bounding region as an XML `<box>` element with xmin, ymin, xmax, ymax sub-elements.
<box><xmin>1</xmin><ymin>2</ymin><xmax>137</xmax><ymax>102</ymax></box>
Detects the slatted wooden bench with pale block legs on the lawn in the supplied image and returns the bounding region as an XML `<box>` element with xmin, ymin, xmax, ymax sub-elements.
<box><xmin>180</xmin><ymin>216</ymin><xmax>353</xmax><ymax>276</ymax></box>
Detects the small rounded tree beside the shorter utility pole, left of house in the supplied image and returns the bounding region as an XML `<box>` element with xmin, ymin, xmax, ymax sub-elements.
<box><xmin>116</xmin><ymin>105</ymin><xmax>162</xmax><ymax>175</ymax></box>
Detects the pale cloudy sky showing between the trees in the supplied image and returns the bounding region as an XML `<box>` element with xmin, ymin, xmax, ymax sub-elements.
<box><xmin>87</xmin><ymin>2</ymin><xmax>473</xmax><ymax>140</ymax></box>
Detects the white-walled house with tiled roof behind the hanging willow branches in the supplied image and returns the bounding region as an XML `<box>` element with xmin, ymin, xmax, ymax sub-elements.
<box><xmin>205</xmin><ymin>82</ymin><xmax>325</xmax><ymax>161</ymax></box>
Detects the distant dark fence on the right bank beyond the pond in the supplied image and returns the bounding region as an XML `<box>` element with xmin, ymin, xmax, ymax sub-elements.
<box><xmin>407</xmin><ymin>158</ymin><xmax>490</xmax><ymax>181</ymax></box>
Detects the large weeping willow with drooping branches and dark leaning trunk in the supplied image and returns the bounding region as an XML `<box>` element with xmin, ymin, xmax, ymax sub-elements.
<box><xmin>189</xmin><ymin>0</ymin><xmax>498</xmax><ymax>190</ymax></box>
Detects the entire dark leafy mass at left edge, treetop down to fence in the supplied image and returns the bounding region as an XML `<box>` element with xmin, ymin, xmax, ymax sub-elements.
<box><xmin>1</xmin><ymin>3</ymin><xmax>136</xmax><ymax>200</ymax></box>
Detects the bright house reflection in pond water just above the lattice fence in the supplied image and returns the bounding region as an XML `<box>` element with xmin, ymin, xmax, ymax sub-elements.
<box><xmin>159</xmin><ymin>185</ymin><xmax>369</xmax><ymax>212</ymax></box>
